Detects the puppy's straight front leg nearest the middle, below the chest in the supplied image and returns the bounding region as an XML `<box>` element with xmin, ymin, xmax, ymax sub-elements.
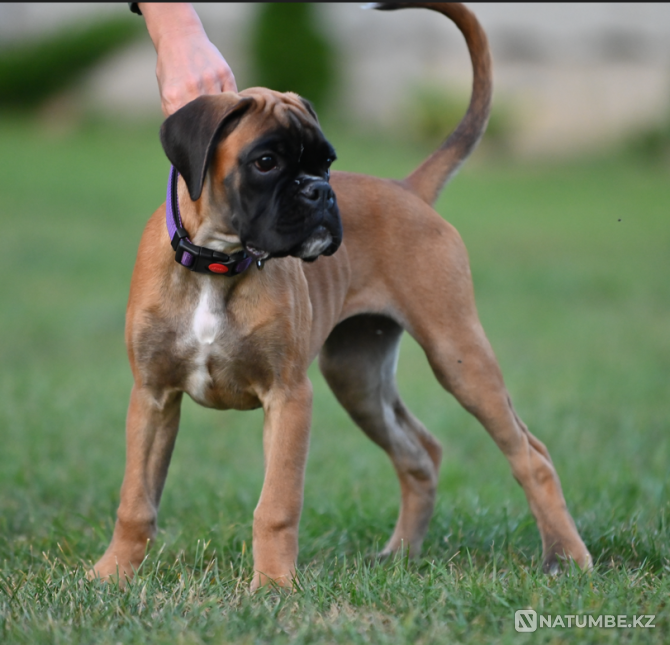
<box><xmin>251</xmin><ymin>377</ymin><xmax>312</xmax><ymax>591</ymax></box>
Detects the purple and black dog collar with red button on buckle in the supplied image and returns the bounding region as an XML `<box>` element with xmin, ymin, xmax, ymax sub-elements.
<box><xmin>165</xmin><ymin>166</ymin><xmax>254</xmax><ymax>276</ymax></box>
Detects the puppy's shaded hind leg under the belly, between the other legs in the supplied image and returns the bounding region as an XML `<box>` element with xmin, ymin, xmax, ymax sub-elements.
<box><xmin>319</xmin><ymin>315</ymin><xmax>442</xmax><ymax>555</ymax></box>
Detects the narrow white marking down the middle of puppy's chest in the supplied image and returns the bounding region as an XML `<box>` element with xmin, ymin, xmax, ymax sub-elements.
<box><xmin>187</xmin><ymin>285</ymin><xmax>225</xmax><ymax>402</ymax></box>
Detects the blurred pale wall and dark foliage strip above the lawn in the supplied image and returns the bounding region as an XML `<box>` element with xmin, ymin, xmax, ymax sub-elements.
<box><xmin>0</xmin><ymin>3</ymin><xmax>670</xmax><ymax>157</ymax></box>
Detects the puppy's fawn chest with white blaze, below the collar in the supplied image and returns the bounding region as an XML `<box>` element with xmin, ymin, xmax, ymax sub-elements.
<box><xmin>135</xmin><ymin>275</ymin><xmax>298</xmax><ymax>410</ymax></box>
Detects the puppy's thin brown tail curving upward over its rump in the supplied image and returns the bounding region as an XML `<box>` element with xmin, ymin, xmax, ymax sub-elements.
<box><xmin>372</xmin><ymin>2</ymin><xmax>493</xmax><ymax>205</ymax></box>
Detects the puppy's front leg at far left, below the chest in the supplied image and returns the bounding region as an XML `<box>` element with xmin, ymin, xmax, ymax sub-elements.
<box><xmin>89</xmin><ymin>386</ymin><xmax>182</xmax><ymax>585</ymax></box>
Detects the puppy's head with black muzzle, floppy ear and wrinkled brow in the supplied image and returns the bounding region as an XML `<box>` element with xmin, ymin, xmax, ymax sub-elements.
<box><xmin>161</xmin><ymin>88</ymin><xmax>342</xmax><ymax>261</ymax></box>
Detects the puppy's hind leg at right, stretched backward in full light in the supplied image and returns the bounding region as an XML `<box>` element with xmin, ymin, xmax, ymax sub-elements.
<box><xmin>395</xmin><ymin>225</ymin><xmax>591</xmax><ymax>572</ymax></box>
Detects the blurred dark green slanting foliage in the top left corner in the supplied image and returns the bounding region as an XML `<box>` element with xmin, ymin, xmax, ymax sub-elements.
<box><xmin>0</xmin><ymin>15</ymin><xmax>143</xmax><ymax>110</ymax></box>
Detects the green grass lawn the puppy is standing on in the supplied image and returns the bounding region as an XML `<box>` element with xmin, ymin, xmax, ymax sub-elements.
<box><xmin>0</xmin><ymin>121</ymin><xmax>670</xmax><ymax>644</ymax></box>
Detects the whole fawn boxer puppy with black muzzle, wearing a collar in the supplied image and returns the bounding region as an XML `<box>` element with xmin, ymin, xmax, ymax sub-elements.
<box><xmin>89</xmin><ymin>3</ymin><xmax>591</xmax><ymax>589</ymax></box>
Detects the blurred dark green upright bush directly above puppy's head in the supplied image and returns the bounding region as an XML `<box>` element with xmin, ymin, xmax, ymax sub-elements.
<box><xmin>250</xmin><ymin>2</ymin><xmax>336</xmax><ymax>110</ymax></box>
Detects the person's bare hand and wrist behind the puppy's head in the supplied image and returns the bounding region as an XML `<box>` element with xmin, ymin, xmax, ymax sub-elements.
<box><xmin>140</xmin><ymin>2</ymin><xmax>237</xmax><ymax>117</ymax></box>
